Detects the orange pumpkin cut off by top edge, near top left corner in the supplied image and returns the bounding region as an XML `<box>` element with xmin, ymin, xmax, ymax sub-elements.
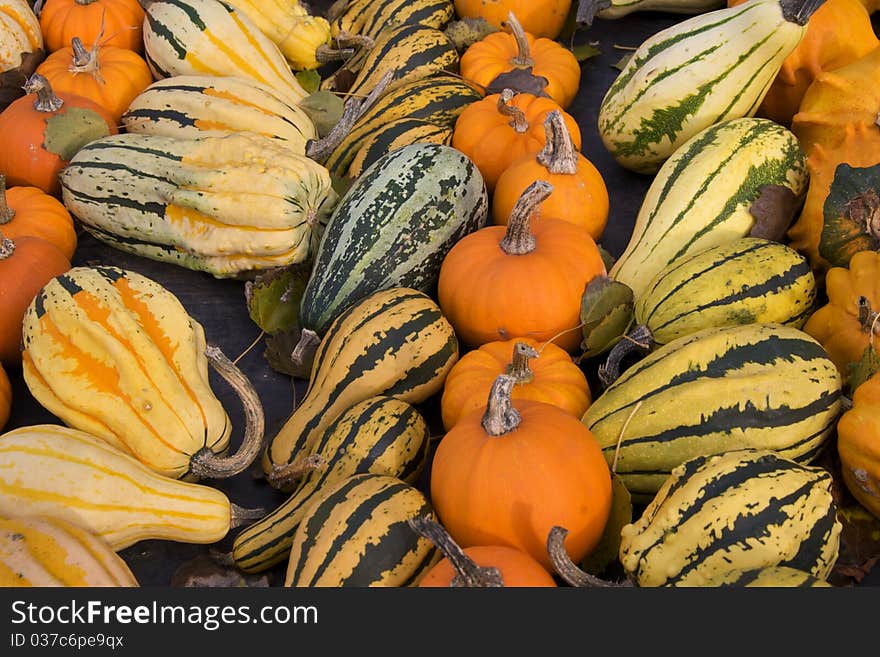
<box><xmin>40</xmin><ymin>0</ymin><xmax>144</xmax><ymax>53</ymax></box>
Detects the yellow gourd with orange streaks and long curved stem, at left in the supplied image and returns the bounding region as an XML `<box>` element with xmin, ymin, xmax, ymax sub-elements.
<box><xmin>22</xmin><ymin>266</ymin><xmax>263</xmax><ymax>479</ymax></box>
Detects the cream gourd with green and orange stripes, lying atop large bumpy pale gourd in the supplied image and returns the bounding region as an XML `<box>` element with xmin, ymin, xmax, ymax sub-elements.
<box><xmin>122</xmin><ymin>75</ymin><xmax>318</xmax><ymax>155</ymax></box>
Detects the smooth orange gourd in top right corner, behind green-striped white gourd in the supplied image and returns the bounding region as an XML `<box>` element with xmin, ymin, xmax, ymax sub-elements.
<box><xmin>727</xmin><ymin>0</ymin><xmax>878</xmax><ymax>126</ymax></box>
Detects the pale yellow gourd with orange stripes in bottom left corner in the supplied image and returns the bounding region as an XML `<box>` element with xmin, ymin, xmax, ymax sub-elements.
<box><xmin>0</xmin><ymin>516</ymin><xmax>138</xmax><ymax>587</ymax></box>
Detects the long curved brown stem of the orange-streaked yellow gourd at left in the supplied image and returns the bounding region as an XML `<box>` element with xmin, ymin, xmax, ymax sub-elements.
<box><xmin>190</xmin><ymin>345</ymin><xmax>266</xmax><ymax>479</ymax></box>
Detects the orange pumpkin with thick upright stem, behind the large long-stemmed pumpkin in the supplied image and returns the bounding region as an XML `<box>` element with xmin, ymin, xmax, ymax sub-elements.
<box><xmin>492</xmin><ymin>110</ymin><xmax>609</xmax><ymax>241</ymax></box>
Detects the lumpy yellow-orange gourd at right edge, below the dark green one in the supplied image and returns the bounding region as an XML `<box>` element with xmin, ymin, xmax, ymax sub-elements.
<box><xmin>804</xmin><ymin>251</ymin><xmax>880</xmax><ymax>380</ymax></box>
